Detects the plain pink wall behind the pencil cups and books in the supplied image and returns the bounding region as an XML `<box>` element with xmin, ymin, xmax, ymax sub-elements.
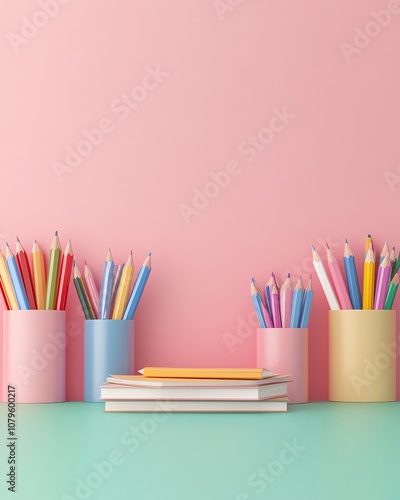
<box><xmin>0</xmin><ymin>0</ymin><xmax>400</xmax><ymax>400</ymax></box>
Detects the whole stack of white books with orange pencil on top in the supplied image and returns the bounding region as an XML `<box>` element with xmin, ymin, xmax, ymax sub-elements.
<box><xmin>100</xmin><ymin>367</ymin><xmax>290</xmax><ymax>413</ymax></box>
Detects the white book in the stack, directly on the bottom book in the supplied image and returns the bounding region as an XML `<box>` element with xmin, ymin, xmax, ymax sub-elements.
<box><xmin>100</xmin><ymin>382</ymin><xmax>287</xmax><ymax>400</ymax></box>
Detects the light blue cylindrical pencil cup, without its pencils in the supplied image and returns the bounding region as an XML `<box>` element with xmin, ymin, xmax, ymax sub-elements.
<box><xmin>84</xmin><ymin>319</ymin><xmax>135</xmax><ymax>403</ymax></box>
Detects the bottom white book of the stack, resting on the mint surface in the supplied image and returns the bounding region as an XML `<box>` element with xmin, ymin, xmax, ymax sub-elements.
<box><xmin>105</xmin><ymin>398</ymin><xmax>287</xmax><ymax>413</ymax></box>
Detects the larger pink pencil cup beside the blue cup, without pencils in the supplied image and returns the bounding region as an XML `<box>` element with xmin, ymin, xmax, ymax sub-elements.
<box><xmin>3</xmin><ymin>310</ymin><xmax>66</xmax><ymax>403</ymax></box>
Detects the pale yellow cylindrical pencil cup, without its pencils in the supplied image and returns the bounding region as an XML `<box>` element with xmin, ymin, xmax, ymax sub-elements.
<box><xmin>329</xmin><ymin>310</ymin><xmax>396</xmax><ymax>403</ymax></box>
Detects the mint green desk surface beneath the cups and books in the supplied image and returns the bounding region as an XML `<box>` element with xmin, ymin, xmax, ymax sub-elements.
<box><xmin>0</xmin><ymin>403</ymin><xmax>400</xmax><ymax>500</ymax></box>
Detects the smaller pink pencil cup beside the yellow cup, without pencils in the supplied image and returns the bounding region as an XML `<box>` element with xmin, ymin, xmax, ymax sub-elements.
<box><xmin>257</xmin><ymin>328</ymin><xmax>308</xmax><ymax>403</ymax></box>
